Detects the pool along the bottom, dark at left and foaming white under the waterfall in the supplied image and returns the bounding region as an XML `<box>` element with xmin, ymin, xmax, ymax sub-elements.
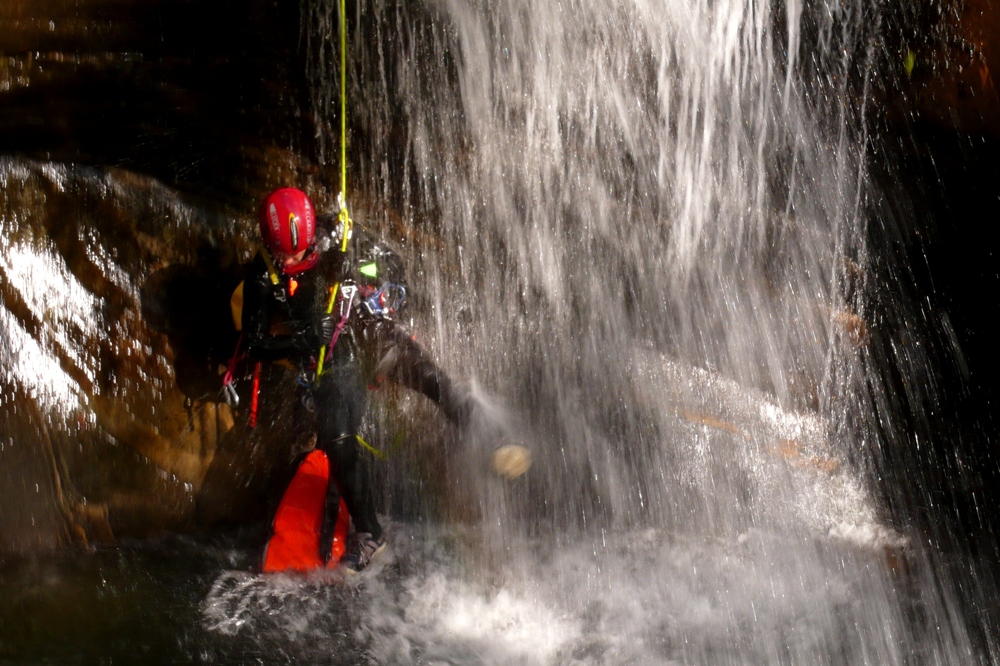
<box><xmin>0</xmin><ymin>523</ymin><xmax>996</xmax><ymax>664</ymax></box>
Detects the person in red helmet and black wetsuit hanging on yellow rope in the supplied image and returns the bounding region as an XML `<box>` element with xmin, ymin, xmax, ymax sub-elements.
<box><xmin>242</xmin><ymin>188</ymin><xmax>470</xmax><ymax>572</ymax></box>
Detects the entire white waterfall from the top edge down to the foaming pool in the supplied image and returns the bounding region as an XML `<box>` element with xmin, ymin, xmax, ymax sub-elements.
<box><xmin>292</xmin><ymin>0</ymin><xmax>990</xmax><ymax>664</ymax></box>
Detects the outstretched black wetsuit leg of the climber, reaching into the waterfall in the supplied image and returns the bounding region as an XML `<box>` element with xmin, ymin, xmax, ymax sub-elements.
<box><xmin>375</xmin><ymin>320</ymin><xmax>472</xmax><ymax>426</ymax></box>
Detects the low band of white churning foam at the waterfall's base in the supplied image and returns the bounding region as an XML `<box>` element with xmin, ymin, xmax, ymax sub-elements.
<box><xmin>203</xmin><ymin>525</ymin><xmax>916</xmax><ymax>664</ymax></box>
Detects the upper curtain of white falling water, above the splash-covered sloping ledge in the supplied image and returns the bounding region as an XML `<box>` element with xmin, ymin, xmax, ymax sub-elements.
<box><xmin>307</xmin><ymin>2</ymin><xmax>868</xmax><ymax>532</ymax></box>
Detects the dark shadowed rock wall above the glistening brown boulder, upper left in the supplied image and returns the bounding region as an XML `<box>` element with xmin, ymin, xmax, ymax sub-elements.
<box><xmin>0</xmin><ymin>0</ymin><xmax>324</xmax><ymax>200</ymax></box>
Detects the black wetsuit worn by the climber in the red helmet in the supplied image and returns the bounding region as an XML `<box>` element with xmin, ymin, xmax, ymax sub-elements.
<box><xmin>243</xmin><ymin>220</ymin><xmax>468</xmax><ymax>555</ymax></box>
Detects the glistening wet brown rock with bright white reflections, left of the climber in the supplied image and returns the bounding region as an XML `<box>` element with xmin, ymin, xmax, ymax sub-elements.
<box><xmin>0</xmin><ymin>158</ymin><xmax>248</xmax><ymax>550</ymax></box>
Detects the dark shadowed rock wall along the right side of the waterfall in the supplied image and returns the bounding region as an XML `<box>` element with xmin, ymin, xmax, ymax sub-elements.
<box><xmin>869</xmin><ymin>0</ymin><xmax>1000</xmax><ymax>544</ymax></box>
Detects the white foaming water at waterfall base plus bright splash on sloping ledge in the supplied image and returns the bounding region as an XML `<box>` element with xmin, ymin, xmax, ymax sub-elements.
<box><xmin>195</xmin><ymin>359</ymin><xmax>944</xmax><ymax>664</ymax></box>
